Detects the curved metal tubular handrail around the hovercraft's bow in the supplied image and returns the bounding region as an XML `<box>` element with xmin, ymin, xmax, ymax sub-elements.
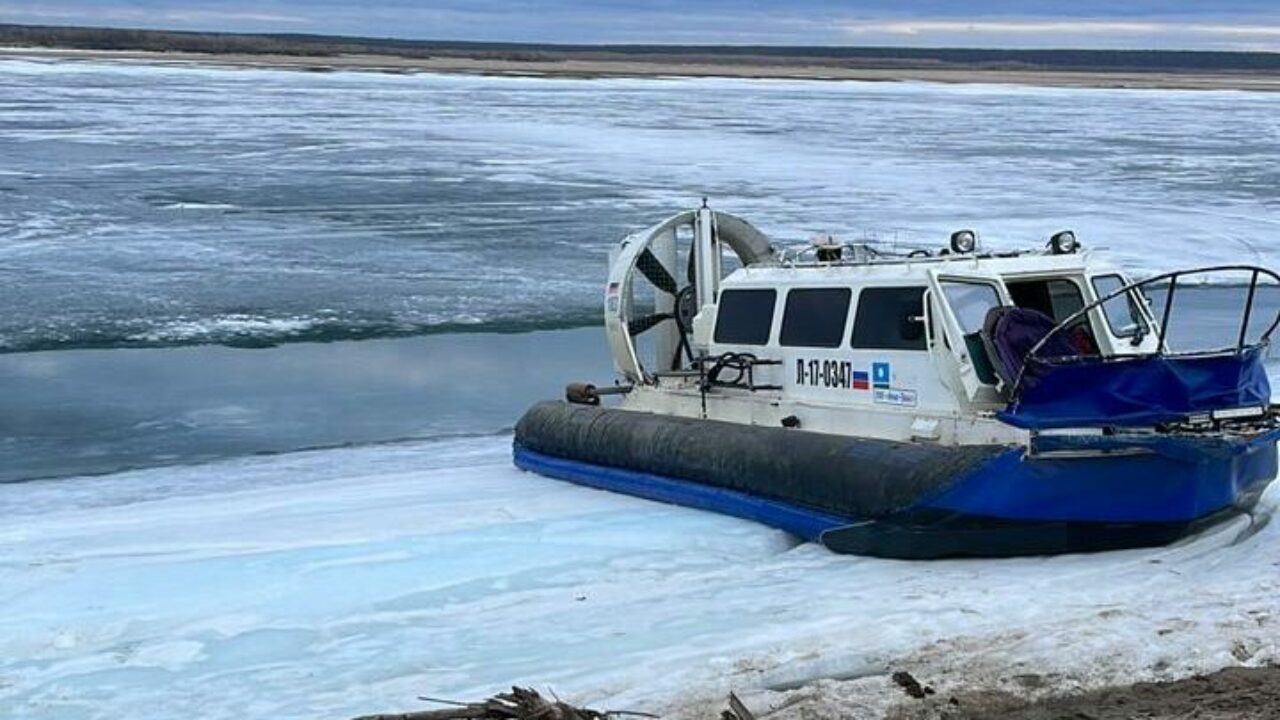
<box><xmin>1010</xmin><ymin>265</ymin><xmax>1280</xmax><ymax>402</ymax></box>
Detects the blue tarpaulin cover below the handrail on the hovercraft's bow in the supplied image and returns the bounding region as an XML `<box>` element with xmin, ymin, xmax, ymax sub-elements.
<box><xmin>1000</xmin><ymin>347</ymin><xmax>1271</xmax><ymax>429</ymax></box>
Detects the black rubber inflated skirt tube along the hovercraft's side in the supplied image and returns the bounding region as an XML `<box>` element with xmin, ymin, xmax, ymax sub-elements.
<box><xmin>516</xmin><ymin>402</ymin><xmax>1006</xmax><ymax>524</ymax></box>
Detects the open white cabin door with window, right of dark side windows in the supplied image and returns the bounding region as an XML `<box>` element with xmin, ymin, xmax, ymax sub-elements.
<box><xmin>929</xmin><ymin>268</ymin><xmax>1012</xmax><ymax>405</ymax></box>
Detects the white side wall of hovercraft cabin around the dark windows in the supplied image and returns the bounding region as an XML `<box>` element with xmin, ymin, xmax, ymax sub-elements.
<box><xmin>621</xmin><ymin>249</ymin><xmax>1114</xmax><ymax>445</ymax></box>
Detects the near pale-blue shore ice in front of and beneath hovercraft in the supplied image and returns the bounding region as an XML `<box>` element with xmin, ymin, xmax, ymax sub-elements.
<box><xmin>0</xmin><ymin>430</ymin><xmax>1280</xmax><ymax>720</ymax></box>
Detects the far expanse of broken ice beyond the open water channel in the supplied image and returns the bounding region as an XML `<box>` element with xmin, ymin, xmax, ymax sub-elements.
<box><xmin>0</xmin><ymin>60</ymin><xmax>1280</xmax><ymax>350</ymax></box>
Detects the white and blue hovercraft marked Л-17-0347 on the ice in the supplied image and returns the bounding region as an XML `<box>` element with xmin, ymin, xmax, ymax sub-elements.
<box><xmin>515</xmin><ymin>202</ymin><xmax>1280</xmax><ymax>559</ymax></box>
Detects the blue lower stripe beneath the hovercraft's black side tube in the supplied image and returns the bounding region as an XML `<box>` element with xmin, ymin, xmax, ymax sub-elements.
<box><xmin>515</xmin><ymin>446</ymin><xmax>849</xmax><ymax>542</ymax></box>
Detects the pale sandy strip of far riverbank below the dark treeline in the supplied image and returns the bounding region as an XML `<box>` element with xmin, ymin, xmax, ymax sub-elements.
<box><xmin>0</xmin><ymin>47</ymin><xmax>1280</xmax><ymax>92</ymax></box>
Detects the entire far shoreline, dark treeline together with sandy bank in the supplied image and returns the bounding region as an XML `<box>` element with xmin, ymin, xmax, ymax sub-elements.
<box><xmin>0</xmin><ymin>24</ymin><xmax>1280</xmax><ymax>91</ymax></box>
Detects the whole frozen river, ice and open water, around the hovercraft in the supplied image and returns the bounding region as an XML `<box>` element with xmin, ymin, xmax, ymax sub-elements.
<box><xmin>0</xmin><ymin>60</ymin><xmax>1280</xmax><ymax>720</ymax></box>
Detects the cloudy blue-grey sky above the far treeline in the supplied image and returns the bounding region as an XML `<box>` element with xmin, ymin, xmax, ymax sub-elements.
<box><xmin>0</xmin><ymin>0</ymin><xmax>1280</xmax><ymax>51</ymax></box>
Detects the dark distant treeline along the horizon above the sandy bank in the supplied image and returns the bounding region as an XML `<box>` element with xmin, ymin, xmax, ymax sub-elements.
<box><xmin>0</xmin><ymin>24</ymin><xmax>1280</xmax><ymax>72</ymax></box>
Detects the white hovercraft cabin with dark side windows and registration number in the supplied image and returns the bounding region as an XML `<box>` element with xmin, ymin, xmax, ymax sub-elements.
<box><xmin>692</xmin><ymin>254</ymin><xmax>1157</xmax><ymax>415</ymax></box>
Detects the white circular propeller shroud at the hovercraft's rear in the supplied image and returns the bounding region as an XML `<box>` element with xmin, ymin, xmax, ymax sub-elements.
<box><xmin>604</xmin><ymin>206</ymin><xmax>774</xmax><ymax>383</ymax></box>
